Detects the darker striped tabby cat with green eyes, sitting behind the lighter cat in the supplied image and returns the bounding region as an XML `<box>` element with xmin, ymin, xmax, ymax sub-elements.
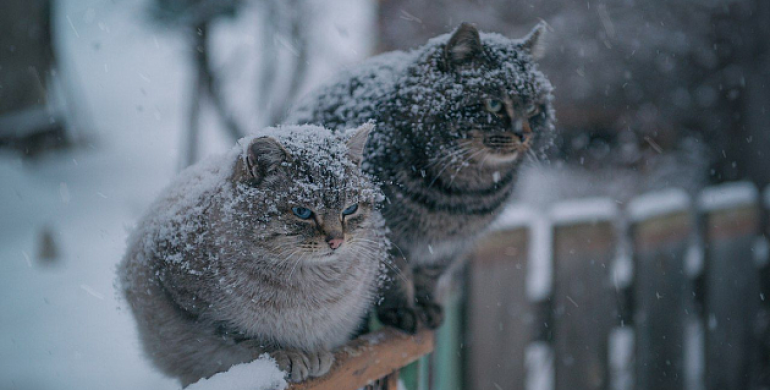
<box><xmin>290</xmin><ymin>24</ymin><xmax>553</xmax><ymax>332</ymax></box>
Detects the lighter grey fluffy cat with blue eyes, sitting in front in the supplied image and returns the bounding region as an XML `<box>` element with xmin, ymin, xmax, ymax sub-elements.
<box><xmin>119</xmin><ymin>124</ymin><xmax>389</xmax><ymax>386</ymax></box>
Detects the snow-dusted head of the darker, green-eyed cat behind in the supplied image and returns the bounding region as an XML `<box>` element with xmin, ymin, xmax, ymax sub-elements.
<box><xmin>400</xmin><ymin>24</ymin><xmax>553</xmax><ymax>164</ymax></box>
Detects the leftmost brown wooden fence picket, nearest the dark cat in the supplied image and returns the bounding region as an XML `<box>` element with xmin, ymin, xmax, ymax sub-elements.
<box><xmin>466</xmin><ymin>228</ymin><xmax>534</xmax><ymax>390</ymax></box>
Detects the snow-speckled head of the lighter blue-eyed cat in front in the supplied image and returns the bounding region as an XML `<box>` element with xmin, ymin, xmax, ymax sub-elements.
<box><xmin>226</xmin><ymin>123</ymin><xmax>381</xmax><ymax>261</ymax></box>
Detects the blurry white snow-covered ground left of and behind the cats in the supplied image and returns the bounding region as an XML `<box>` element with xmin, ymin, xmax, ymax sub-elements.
<box><xmin>0</xmin><ymin>0</ymin><xmax>373</xmax><ymax>389</ymax></box>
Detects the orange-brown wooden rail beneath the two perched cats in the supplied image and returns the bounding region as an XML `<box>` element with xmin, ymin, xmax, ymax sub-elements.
<box><xmin>289</xmin><ymin>328</ymin><xmax>433</xmax><ymax>390</ymax></box>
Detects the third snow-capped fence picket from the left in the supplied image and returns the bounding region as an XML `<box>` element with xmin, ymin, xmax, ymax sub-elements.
<box><xmin>628</xmin><ymin>190</ymin><xmax>694</xmax><ymax>390</ymax></box>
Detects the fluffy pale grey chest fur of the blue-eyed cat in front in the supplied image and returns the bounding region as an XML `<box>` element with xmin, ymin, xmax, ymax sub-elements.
<box><xmin>206</xmin><ymin>245</ymin><xmax>378</xmax><ymax>350</ymax></box>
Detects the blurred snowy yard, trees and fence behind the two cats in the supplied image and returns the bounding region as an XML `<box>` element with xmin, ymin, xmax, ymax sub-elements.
<box><xmin>0</xmin><ymin>0</ymin><xmax>770</xmax><ymax>390</ymax></box>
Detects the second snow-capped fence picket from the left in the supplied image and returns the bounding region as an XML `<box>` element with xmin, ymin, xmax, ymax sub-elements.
<box><xmin>550</xmin><ymin>198</ymin><xmax>617</xmax><ymax>390</ymax></box>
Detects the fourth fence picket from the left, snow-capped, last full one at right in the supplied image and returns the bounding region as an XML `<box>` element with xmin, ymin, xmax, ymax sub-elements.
<box><xmin>698</xmin><ymin>183</ymin><xmax>761</xmax><ymax>390</ymax></box>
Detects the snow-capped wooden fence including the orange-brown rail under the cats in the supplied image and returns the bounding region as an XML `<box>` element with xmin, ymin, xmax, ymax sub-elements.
<box><xmin>292</xmin><ymin>183</ymin><xmax>770</xmax><ymax>390</ymax></box>
